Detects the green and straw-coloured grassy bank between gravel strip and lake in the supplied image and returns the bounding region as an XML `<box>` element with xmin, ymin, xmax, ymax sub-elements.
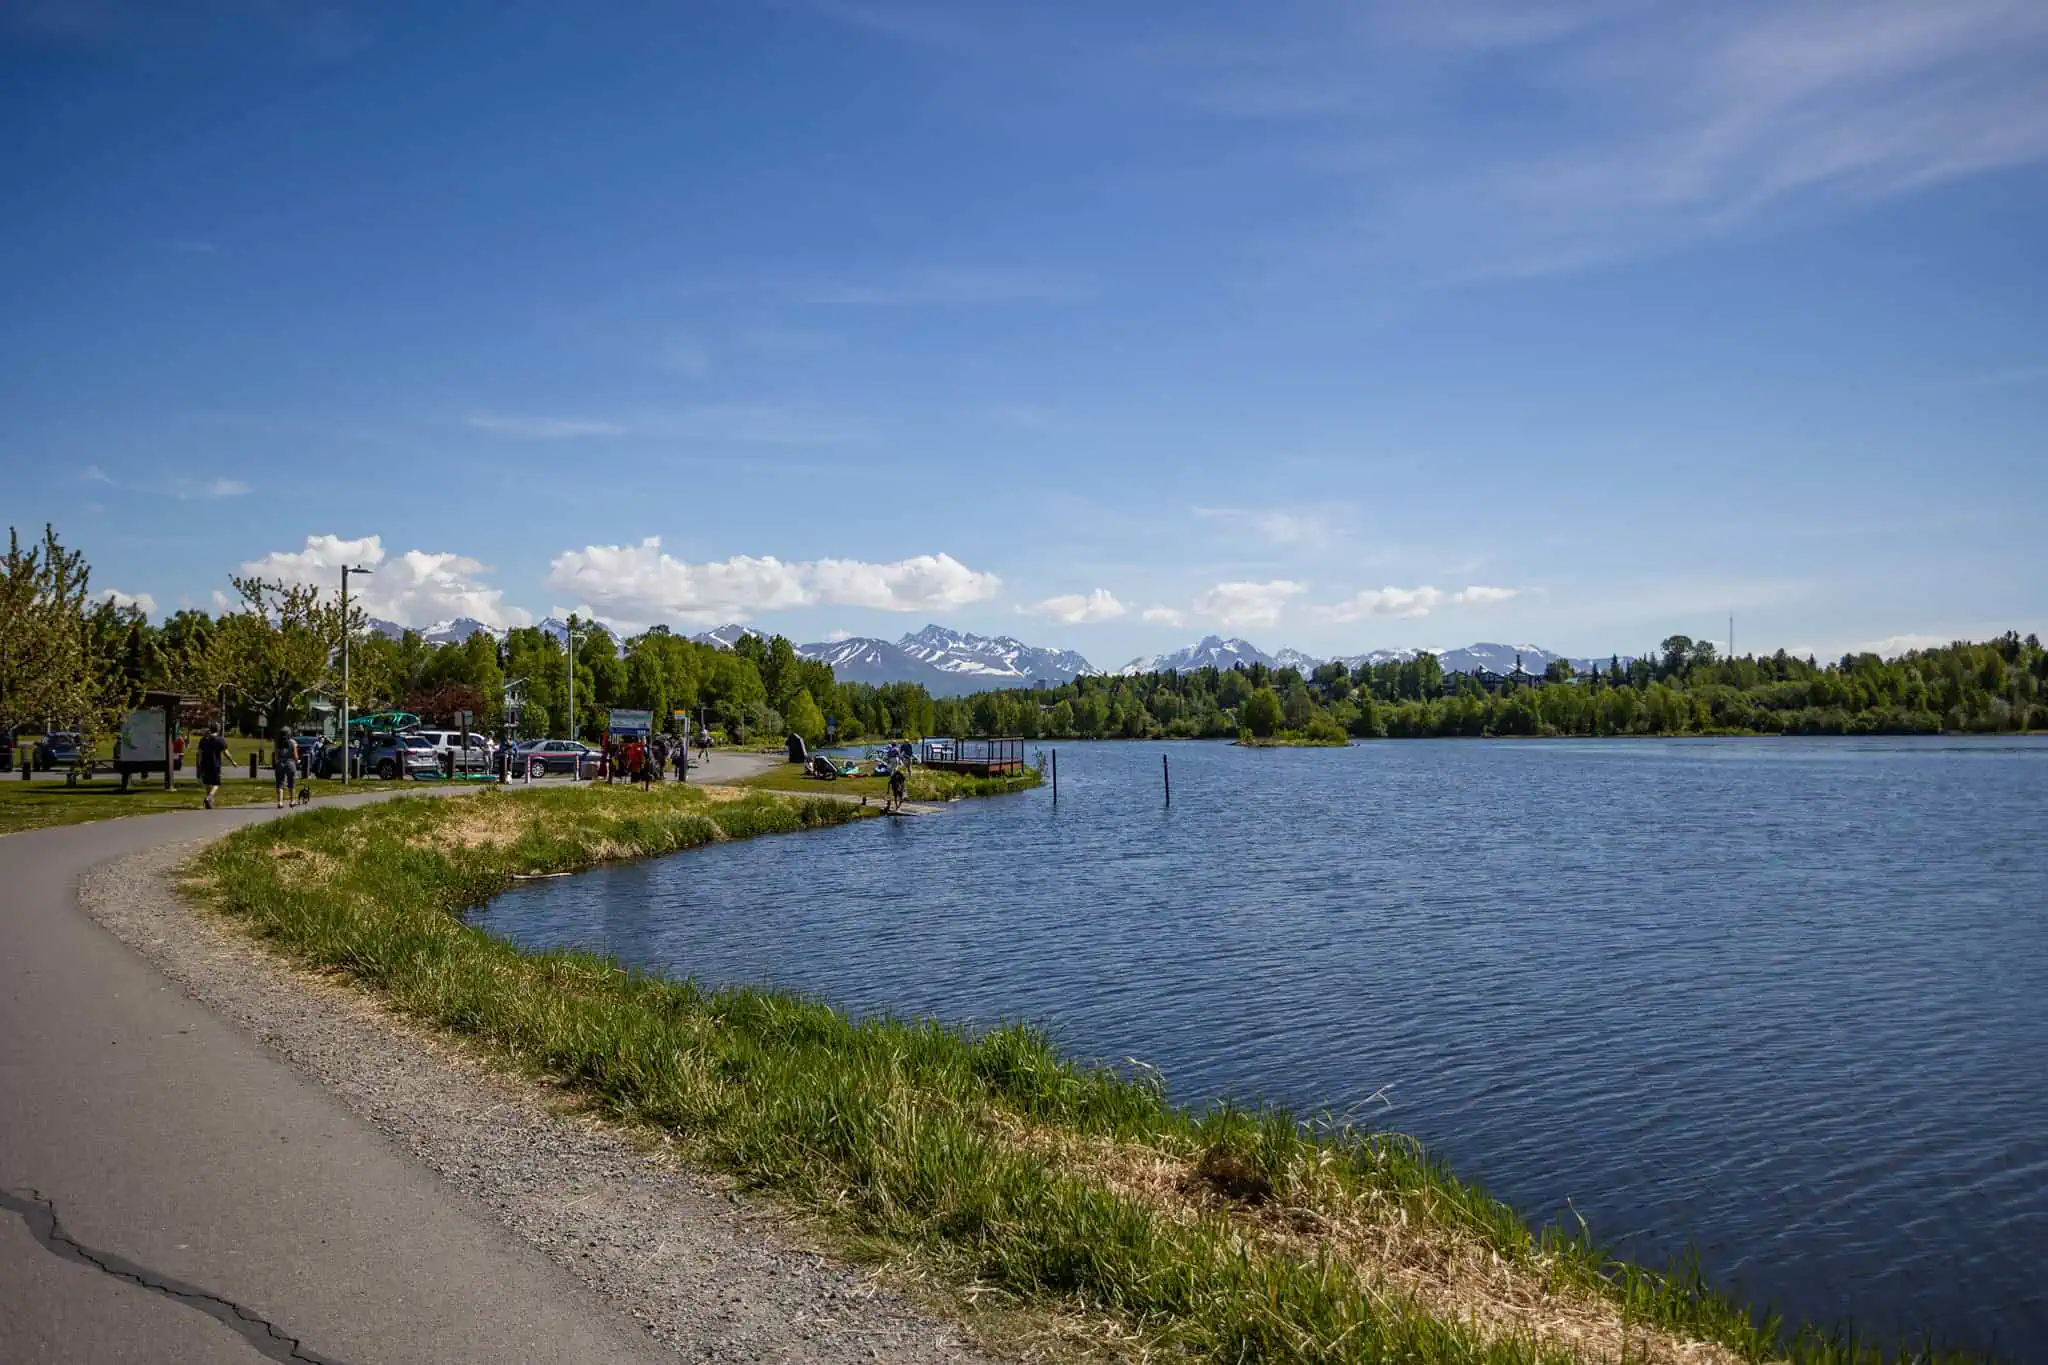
<box><xmin>186</xmin><ymin>786</ymin><xmax>1974</xmax><ymax>1363</ymax></box>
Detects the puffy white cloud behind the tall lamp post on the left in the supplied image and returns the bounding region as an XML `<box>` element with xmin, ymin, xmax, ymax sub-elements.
<box><xmin>242</xmin><ymin>536</ymin><xmax>532</xmax><ymax>630</ymax></box>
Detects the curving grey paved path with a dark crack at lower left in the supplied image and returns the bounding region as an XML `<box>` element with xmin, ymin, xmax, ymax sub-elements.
<box><xmin>0</xmin><ymin>789</ymin><xmax>671</xmax><ymax>1365</ymax></box>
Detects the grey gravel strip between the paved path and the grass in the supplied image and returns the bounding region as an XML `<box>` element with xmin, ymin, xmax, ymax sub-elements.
<box><xmin>80</xmin><ymin>841</ymin><xmax>991</xmax><ymax>1365</ymax></box>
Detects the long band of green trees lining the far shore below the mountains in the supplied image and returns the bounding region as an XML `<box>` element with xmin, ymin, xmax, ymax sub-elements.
<box><xmin>0</xmin><ymin>528</ymin><xmax>2048</xmax><ymax>743</ymax></box>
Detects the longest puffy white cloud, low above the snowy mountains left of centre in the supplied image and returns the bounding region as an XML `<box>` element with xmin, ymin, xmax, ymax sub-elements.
<box><xmin>547</xmin><ymin>536</ymin><xmax>1001</xmax><ymax>624</ymax></box>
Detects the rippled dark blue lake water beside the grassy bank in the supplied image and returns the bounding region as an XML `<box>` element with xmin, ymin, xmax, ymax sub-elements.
<box><xmin>477</xmin><ymin>739</ymin><xmax>2048</xmax><ymax>1361</ymax></box>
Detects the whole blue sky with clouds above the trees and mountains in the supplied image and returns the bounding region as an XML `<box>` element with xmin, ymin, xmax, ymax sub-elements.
<box><xmin>0</xmin><ymin>0</ymin><xmax>2048</xmax><ymax>663</ymax></box>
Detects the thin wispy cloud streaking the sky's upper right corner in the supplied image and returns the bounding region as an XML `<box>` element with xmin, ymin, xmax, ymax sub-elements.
<box><xmin>1362</xmin><ymin>0</ymin><xmax>2048</xmax><ymax>274</ymax></box>
